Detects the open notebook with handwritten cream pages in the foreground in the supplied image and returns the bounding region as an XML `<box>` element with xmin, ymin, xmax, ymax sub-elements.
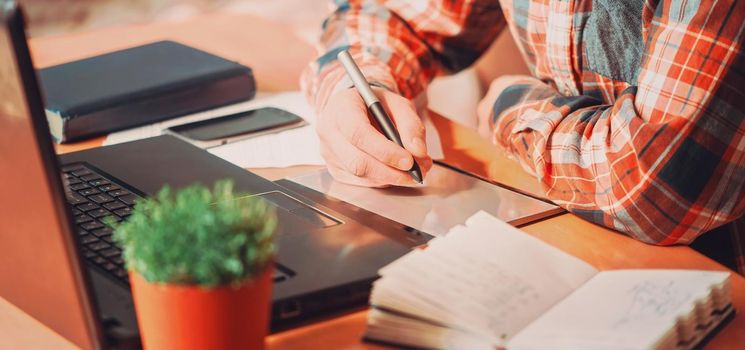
<box><xmin>365</xmin><ymin>212</ymin><xmax>734</xmax><ymax>349</ymax></box>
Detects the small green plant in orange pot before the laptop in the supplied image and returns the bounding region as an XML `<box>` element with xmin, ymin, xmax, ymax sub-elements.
<box><xmin>110</xmin><ymin>181</ymin><xmax>276</xmax><ymax>349</ymax></box>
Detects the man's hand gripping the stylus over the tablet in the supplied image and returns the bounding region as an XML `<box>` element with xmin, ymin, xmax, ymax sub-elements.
<box><xmin>316</xmin><ymin>88</ymin><xmax>432</xmax><ymax>187</ymax></box>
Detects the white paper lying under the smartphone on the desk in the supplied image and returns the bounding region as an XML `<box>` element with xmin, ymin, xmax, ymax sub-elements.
<box><xmin>104</xmin><ymin>91</ymin><xmax>443</xmax><ymax>168</ymax></box>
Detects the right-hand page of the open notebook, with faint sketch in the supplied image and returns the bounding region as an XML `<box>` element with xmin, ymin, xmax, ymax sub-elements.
<box><xmin>508</xmin><ymin>270</ymin><xmax>729</xmax><ymax>350</ymax></box>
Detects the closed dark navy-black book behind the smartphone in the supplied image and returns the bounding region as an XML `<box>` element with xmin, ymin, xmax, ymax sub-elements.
<box><xmin>39</xmin><ymin>41</ymin><xmax>256</xmax><ymax>143</ymax></box>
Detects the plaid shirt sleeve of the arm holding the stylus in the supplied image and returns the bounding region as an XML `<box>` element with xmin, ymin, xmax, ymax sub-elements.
<box><xmin>301</xmin><ymin>0</ymin><xmax>505</xmax><ymax>111</ymax></box>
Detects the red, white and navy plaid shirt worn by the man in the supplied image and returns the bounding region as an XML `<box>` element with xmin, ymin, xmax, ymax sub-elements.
<box><xmin>303</xmin><ymin>0</ymin><xmax>745</xmax><ymax>271</ymax></box>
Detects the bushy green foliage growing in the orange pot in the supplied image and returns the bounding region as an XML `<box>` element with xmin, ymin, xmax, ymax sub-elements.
<box><xmin>109</xmin><ymin>180</ymin><xmax>277</xmax><ymax>287</ymax></box>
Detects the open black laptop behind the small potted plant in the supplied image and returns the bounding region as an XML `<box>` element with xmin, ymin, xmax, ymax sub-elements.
<box><xmin>0</xmin><ymin>0</ymin><xmax>557</xmax><ymax>349</ymax></box>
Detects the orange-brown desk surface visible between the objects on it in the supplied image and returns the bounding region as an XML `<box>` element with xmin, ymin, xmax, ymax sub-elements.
<box><xmin>0</xmin><ymin>14</ymin><xmax>745</xmax><ymax>349</ymax></box>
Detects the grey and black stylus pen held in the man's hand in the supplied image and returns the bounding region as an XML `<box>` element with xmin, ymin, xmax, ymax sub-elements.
<box><xmin>337</xmin><ymin>50</ymin><xmax>422</xmax><ymax>183</ymax></box>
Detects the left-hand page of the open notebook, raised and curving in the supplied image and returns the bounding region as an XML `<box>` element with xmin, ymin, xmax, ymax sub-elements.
<box><xmin>370</xmin><ymin>212</ymin><xmax>597</xmax><ymax>344</ymax></box>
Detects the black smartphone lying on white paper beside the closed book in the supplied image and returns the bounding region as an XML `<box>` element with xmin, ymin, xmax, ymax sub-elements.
<box><xmin>166</xmin><ymin>107</ymin><xmax>306</xmax><ymax>148</ymax></box>
